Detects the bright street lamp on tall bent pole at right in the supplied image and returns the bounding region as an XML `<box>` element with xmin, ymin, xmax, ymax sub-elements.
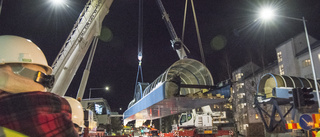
<box><xmin>260</xmin><ymin>6</ymin><xmax>320</xmax><ymax>113</ymax></box>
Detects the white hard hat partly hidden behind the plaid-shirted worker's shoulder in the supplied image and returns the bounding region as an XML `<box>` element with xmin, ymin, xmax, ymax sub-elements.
<box><xmin>64</xmin><ymin>96</ymin><xmax>85</xmax><ymax>128</ymax></box>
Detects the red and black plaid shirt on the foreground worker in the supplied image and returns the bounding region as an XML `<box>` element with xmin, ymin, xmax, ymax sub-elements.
<box><xmin>0</xmin><ymin>92</ymin><xmax>78</xmax><ymax>137</ymax></box>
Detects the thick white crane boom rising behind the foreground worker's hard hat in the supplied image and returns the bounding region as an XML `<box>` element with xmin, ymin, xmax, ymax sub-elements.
<box><xmin>49</xmin><ymin>0</ymin><xmax>113</xmax><ymax>96</ymax></box>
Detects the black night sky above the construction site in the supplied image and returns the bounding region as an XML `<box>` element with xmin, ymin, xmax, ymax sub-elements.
<box><xmin>0</xmin><ymin>0</ymin><xmax>320</xmax><ymax>111</ymax></box>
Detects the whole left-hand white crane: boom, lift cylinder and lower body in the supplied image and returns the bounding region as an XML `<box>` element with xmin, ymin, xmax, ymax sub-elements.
<box><xmin>48</xmin><ymin>0</ymin><xmax>113</xmax><ymax>135</ymax></box>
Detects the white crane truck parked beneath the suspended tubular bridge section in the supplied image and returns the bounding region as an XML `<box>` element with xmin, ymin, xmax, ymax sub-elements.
<box><xmin>161</xmin><ymin>80</ymin><xmax>233</xmax><ymax>137</ymax></box>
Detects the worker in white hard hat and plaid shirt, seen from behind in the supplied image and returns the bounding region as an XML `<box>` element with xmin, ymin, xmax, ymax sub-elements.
<box><xmin>0</xmin><ymin>35</ymin><xmax>78</xmax><ymax>137</ymax></box>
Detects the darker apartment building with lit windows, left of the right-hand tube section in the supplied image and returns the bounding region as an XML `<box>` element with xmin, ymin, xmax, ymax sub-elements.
<box><xmin>232</xmin><ymin>62</ymin><xmax>279</xmax><ymax>137</ymax></box>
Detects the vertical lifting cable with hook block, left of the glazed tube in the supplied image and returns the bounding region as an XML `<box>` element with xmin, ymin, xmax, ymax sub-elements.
<box><xmin>135</xmin><ymin>0</ymin><xmax>143</xmax><ymax>90</ymax></box>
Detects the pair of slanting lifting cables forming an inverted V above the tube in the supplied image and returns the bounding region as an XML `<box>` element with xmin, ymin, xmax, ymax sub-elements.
<box><xmin>182</xmin><ymin>0</ymin><xmax>206</xmax><ymax>66</ymax></box>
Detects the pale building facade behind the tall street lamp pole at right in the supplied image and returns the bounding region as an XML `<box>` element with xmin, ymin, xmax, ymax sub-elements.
<box><xmin>276</xmin><ymin>33</ymin><xmax>320</xmax><ymax>78</ymax></box>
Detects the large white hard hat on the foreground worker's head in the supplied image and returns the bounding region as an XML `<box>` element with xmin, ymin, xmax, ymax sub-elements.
<box><xmin>0</xmin><ymin>35</ymin><xmax>52</xmax><ymax>74</ymax></box>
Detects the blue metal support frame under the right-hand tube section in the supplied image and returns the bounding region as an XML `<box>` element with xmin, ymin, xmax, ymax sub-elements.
<box><xmin>254</xmin><ymin>98</ymin><xmax>295</xmax><ymax>132</ymax></box>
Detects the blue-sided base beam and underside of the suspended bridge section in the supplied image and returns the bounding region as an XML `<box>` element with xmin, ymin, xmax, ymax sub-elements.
<box><xmin>123</xmin><ymin>82</ymin><xmax>230</xmax><ymax>121</ymax></box>
